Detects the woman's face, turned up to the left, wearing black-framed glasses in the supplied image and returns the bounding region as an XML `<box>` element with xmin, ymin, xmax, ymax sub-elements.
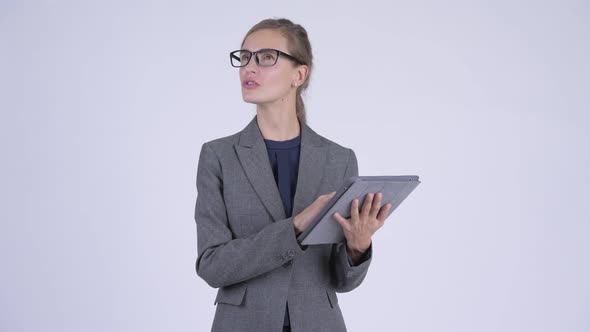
<box><xmin>240</xmin><ymin>29</ymin><xmax>306</xmax><ymax>105</ymax></box>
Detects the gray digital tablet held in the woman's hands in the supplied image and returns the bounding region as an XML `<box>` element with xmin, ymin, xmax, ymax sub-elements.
<box><xmin>297</xmin><ymin>175</ymin><xmax>420</xmax><ymax>245</ymax></box>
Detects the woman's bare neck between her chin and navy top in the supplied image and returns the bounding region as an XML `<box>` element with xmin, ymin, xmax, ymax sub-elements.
<box><xmin>256</xmin><ymin>100</ymin><xmax>301</xmax><ymax>141</ymax></box>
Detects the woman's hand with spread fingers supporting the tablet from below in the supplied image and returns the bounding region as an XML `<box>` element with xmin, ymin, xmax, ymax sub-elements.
<box><xmin>334</xmin><ymin>192</ymin><xmax>391</xmax><ymax>262</ymax></box>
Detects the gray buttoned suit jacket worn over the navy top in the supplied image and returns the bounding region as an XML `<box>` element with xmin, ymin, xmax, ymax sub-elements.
<box><xmin>195</xmin><ymin>116</ymin><xmax>372</xmax><ymax>332</ymax></box>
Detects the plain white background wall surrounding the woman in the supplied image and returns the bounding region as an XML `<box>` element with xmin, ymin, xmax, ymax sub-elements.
<box><xmin>0</xmin><ymin>0</ymin><xmax>590</xmax><ymax>332</ymax></box>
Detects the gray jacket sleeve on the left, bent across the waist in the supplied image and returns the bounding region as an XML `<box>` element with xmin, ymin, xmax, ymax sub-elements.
<box><xmin>195</xmin><ymin>143</ymin><xmax>303</xmax><ymax>288</ymax></box>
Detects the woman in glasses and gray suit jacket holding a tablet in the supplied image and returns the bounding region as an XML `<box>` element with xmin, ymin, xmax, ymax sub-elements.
<box><xmin>195</xmin><ymin>19</ymin><xmax>390</xmax><ymax>332</ymax></box>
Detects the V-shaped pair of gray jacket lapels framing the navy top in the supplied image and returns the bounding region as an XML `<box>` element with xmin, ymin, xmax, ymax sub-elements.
<box><xmin>235</xmin><ymin>116</ymin><xmax>327</xmax><ymax>221</ymax></box>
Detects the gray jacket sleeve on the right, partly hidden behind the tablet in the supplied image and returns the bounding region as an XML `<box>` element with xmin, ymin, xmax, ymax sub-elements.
<box><xmin>330</xmin><ymin>149</ymin><xmax>373</xmax><ymax>293</ymax></box>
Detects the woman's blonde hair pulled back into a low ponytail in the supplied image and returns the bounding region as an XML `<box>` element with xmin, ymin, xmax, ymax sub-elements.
<box><xmin>242</xmin><ymin>18</ymin><xmax>313</xmax><ymax>124</ymax></box>
